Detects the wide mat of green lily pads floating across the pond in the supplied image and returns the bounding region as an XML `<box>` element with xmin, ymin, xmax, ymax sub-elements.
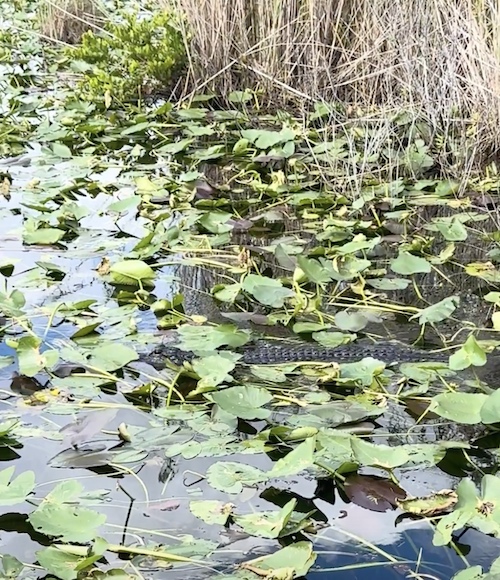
<box><xmin>0</xmin><ymin>2</ymin><xmax>500</xmax><ymax>580</ymax></box>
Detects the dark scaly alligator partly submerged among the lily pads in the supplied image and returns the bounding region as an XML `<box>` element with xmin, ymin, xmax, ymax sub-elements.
<box><xmin>141</xmin><ymin>340</ymin><xmax>449</xmax><ymax>370</ymax></box>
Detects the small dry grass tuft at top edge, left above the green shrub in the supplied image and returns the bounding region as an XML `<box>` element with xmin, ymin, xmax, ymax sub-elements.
<box><xmin>39</xmin><ymin>0</ymin><xmax>106</xmax><ymax>44</ymax></box>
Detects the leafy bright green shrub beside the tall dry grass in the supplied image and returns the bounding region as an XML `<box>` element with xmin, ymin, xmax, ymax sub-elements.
<box><xmin>67</xmin><ymin>12</ymin><xmax>186</xmax><ymax>101</ymax></box>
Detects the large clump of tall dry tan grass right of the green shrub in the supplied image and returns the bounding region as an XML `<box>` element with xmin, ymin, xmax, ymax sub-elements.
<box><xmin>165</xmin><ymin>0</ymin><xmax>500</xmax><ymax>172</ymax></box>
